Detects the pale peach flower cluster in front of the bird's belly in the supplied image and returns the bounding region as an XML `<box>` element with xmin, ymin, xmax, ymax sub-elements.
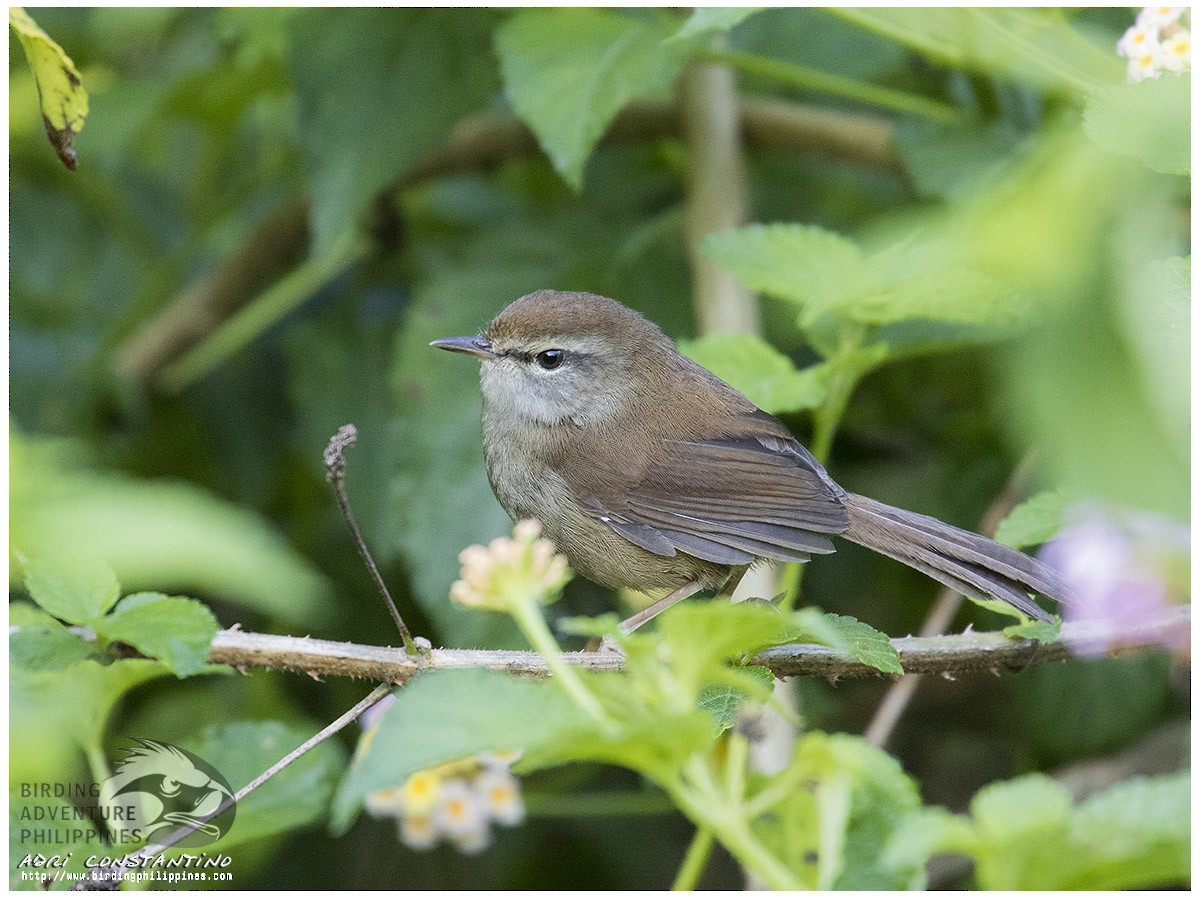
<box><xmin>450</xmin><ymin>518</ymin><xmax>571</xmax><ymax>612</ymax></box>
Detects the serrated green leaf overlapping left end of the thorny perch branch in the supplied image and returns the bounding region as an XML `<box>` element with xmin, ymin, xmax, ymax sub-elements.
<box><xmin>94</xmin><ymin>593</ymin><xmax>218</xmax><ymax>678</ymax></box>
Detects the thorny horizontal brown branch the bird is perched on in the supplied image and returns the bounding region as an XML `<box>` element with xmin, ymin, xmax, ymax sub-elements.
<box><xmin>201</xmin><ymin>606</ymin><xmax>1192</xmax><ymax>684</ymax></box>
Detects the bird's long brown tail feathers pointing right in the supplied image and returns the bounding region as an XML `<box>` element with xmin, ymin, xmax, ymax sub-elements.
<box><xmin>841</xmin><ymin>493</ymin><xmax>1068</xmax><ymax>622</ymax></box>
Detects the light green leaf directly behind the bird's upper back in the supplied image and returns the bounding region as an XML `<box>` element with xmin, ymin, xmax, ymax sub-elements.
<box><xmin>679</xmin><ymin>335</ymin><xmax>828</xmax><ymax>414</ymax></box>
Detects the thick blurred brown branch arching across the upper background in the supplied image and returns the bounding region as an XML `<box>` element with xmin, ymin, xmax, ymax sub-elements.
<box><xmin>114</xmin><ymin>98</ymin><xmax>902</xmax><ymax>389</ymax></box>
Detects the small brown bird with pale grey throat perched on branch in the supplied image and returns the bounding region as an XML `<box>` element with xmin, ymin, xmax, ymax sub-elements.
<box><xmin>432</xmin><ymin>290</ymin><xmax>1067</xmax><ymax>631</ymax></box>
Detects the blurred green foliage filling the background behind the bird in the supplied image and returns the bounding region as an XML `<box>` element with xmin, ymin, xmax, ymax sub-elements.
<box><xmin>10</xmin><ymin>8</ymin><xmax>1190</xmax><ymax>889</ymax></box>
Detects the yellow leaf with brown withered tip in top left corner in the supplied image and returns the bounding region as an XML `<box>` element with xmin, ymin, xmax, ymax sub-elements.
<box><xmin>8</xmin><ymin>6</ymin><xmax>88</xmax><ymax>169</ymax></box>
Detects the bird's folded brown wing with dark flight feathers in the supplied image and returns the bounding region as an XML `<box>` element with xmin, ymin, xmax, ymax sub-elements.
<box><xmin>568</xmin><ymin>437</ymin><xmax>848</xmax><ymax>565</ymax></box>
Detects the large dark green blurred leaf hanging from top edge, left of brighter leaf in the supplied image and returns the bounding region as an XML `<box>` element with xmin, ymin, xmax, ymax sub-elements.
<box><xmin>287</xmin><ymin>8</ymin><xmax>497</xmax><ymax>252</ymax></box>
